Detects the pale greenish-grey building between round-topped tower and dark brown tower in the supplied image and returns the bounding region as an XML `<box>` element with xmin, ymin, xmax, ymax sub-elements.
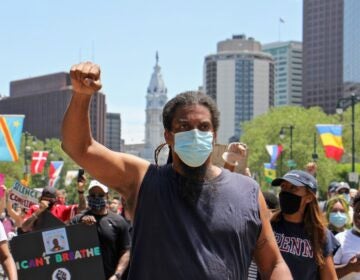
<box><xmin>262</xmin><ymin>41</ymin><xmax>302</xmax><ymax>107</ymax></box>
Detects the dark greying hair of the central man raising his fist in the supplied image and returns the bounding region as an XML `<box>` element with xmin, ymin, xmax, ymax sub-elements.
<box><xmin>162</xmin><ymin>91</ymin><xmax>220</xmax><ymax>132</ymax></box>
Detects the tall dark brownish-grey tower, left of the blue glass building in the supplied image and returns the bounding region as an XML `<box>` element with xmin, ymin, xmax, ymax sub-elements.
<box><xmin>303</xmin><ymin>0</ymin><xmax>344</xmax><ymax>113</ymax></box>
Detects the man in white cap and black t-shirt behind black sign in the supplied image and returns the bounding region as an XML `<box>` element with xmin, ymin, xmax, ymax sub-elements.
<box><xmin>71</xmin><ymin>180</ymin><xmax>130</xmax><ymax>280</ymax></box>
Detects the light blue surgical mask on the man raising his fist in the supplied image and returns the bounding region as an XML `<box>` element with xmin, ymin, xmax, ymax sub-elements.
<box><xmin>174</xmin><ymin>129</ymin><xmax>213</xmax><ymax>167</ymax></box>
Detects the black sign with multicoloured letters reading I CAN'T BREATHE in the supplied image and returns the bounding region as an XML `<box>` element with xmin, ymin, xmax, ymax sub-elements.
<box><xmin>10</xmin><ymin>224</ymin><xmax>105</xmax><ymax>280</ymax></box>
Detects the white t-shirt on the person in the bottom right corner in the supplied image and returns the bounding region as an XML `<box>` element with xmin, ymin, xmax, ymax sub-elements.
<box><xmin>334</xmin><ymin>229</ymin><xmax>360</xmax><ymax>280</ymax></box>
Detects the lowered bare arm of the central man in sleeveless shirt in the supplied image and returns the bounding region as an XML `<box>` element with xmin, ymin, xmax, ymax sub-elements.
<box><xmin>254</xmin><ymin>192</ymin><xmax>292</xmax><ymax>280</ymax></box>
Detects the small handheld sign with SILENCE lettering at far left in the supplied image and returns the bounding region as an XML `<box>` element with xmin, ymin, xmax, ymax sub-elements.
<box><xmin>9</xmin><ymin>181</ymin><xmax>41</xmax><ymax>209</ymax></box>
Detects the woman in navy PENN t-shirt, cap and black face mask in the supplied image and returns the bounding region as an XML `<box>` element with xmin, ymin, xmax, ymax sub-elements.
<box><xmin>271</xmin><ymin>170</ymin><xmax>340</xmax><ymax>280</ymax></box>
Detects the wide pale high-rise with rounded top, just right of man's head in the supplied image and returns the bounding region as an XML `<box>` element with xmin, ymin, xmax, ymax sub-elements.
<box><xmin>204</xmin><ymin>35</ymin><xmax>274</xmax><ymax>144</ymax></box>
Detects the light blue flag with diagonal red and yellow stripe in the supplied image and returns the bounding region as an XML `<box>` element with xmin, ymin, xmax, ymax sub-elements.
<box><xmin>0</xmin><ymin>115</ymin><xmax>25</xmax><ymax>161</ymax></box>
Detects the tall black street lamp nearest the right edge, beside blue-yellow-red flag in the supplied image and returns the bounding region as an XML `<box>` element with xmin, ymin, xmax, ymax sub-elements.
<box><xmin>336</xmin><ymin>92</ymin><xmax>360</xmax><ymax>177</ymax></box>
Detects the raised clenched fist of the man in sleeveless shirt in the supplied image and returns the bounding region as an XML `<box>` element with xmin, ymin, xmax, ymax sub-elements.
<box><xmin>70</xmin><ymin>62</ymin><xmax>101</xmax><ymax>95</ymax></box>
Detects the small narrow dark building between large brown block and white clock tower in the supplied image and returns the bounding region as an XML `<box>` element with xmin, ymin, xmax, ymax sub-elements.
<box><xmin>105</xmin><ymin>113</ymin><xmax>122</xmax><ymax>152</ymax></box>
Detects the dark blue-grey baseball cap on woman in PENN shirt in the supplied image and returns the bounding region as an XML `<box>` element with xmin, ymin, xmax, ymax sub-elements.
<box><xmin>271</xmin><ymin>170</ymin><xmax>317</xmax><ymax>193</ymax></box>
